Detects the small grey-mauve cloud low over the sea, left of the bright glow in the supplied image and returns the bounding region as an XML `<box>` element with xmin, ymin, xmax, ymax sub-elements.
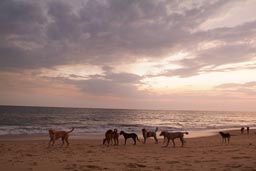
<box><xmin>64</xmin><ymin>66</ymin><xmax>142</xmax><ymax>97</ymax></box>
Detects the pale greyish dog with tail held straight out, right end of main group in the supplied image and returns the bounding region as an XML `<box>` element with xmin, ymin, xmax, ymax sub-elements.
<box><xmin>160</xmin><ymin>131</ymin><xmax>188</xmax><ymax>147</ymax></box>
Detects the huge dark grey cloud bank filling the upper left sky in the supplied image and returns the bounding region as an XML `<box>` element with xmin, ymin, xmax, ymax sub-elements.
<box><xmin>0</xmin><ymin>0</ymin><xmax>245</xmax><ymax>68</ymax></box>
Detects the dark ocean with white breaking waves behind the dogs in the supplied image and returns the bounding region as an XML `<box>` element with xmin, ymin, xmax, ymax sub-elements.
<box><xmin>0</xmin><ymin>106</ymin><xmax>256</xmax><ymax>136</ymax></box>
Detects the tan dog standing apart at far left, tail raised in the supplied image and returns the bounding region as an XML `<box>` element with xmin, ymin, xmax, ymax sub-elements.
<box><xmin>48</xmin><ymin>128</ymin><xmax>75</xmax><ymax>146</ymax></box>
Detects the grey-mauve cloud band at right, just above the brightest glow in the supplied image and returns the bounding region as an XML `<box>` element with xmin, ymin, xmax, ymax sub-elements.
<box><xmin>160</xmin><ymin>18</ymin><xmax>256</xmax><ymax>77</ymax></box>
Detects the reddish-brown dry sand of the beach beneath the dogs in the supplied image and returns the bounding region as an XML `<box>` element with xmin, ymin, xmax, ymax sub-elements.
<box><xmin>0</xmin><ymin>131</ymin><xmax>256</xmax><ymax>171</ymax></box>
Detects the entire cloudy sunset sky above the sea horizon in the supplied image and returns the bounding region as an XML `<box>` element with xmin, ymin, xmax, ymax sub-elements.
<box><xmin>0</xmin><ymin>0</ymin><xmax>256</xmax><ymax>111</ymax></box>
